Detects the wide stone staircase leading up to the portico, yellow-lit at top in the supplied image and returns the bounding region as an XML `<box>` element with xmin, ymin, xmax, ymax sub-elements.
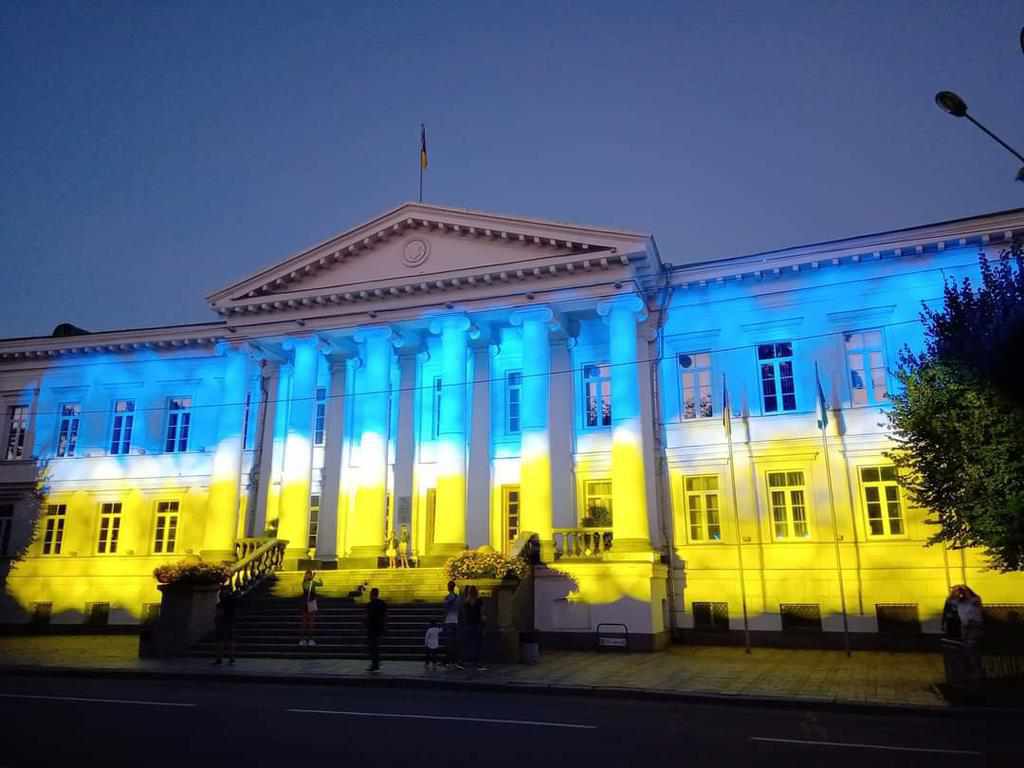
<box><xmin>193</xmin><ymin>568</ymin><xmax>447</xmax><ymax>660</ymax></box>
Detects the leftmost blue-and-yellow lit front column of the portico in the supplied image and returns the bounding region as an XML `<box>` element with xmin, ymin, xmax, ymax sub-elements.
<box><xmin>202</xmin><ymin>346</ymin><xmax>249</xmax><ymax>559</ymax></box>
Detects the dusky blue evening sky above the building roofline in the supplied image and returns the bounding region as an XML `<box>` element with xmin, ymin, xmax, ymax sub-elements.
<box><xmin>0</xmin><ymin>0</ymin><xmax>1024</xmax><ymax>337</ymax></box>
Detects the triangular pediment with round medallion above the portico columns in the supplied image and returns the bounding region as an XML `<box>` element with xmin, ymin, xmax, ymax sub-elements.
<box><xmin>209</xmin><ymin>203</ymin><xmax>657</xmax><ymax>315</ymax></box>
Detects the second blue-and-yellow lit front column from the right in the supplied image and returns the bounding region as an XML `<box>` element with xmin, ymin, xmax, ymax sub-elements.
<box><xmin>510</xmin><ymin>307</ymin><xmax>554</xmax><ymax>560</ymax></box>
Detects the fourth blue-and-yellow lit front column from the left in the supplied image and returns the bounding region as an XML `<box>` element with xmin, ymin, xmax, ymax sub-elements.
<box><xmin>430</xmin><ymin>314</ymin><xmax>472</xmax><ymax>555</ymax></box>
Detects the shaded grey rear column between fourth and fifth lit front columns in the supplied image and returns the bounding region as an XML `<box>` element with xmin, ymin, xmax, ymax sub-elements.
<box><xmin>466</xmin><ymin>344</ymin><xmax>491</xmax><ymax>551</ymax></box>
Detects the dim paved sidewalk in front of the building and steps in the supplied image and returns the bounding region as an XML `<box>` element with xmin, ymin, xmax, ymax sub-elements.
<box><xmin>0</xmin><ymin>636</ymin><xmax>948</xmax><ymax>709</ymax></box>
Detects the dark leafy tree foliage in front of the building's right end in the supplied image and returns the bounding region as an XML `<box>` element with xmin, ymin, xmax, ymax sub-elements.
<box><xmin>887</xmin><ymin>243</ymin><xmax>1024</xmax><ymax>571</ymax></box>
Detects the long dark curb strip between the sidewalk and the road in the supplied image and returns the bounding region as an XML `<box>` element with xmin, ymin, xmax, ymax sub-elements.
<box><xmin>0</xmin><ymin>665</ymin><xmax>1022</xmax><ymax>717</ymax></box>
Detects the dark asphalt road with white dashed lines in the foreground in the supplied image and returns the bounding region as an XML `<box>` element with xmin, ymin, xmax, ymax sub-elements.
<box><xmin>0</xmin><ymin>676</ymin><xmax>1024</xmax><ymax>768</ymax></box>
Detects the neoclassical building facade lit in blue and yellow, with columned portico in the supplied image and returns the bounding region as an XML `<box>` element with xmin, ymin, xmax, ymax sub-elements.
<box><xmin>0</xmin><ymin>204</ymin><xmax>1024</xmax><ymax>647</ymax></box>
